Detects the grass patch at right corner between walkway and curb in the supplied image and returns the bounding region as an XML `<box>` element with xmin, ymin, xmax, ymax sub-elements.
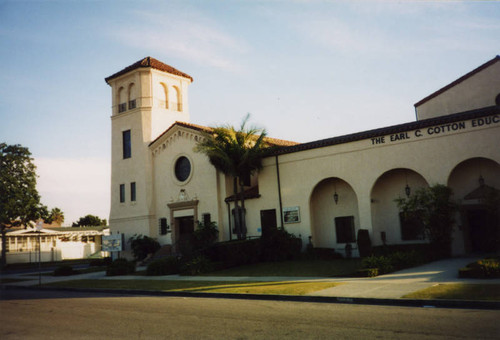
<box><xmin>403</xmin><ymin>283</ymin><xmax>500</xmax><ymax>301</ymax></box>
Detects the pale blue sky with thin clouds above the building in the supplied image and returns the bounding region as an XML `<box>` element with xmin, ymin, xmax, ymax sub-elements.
<box><xmin>0</xmin><ymin>0</ymin><xmax>500</xmax><ymax>225</ymax></box>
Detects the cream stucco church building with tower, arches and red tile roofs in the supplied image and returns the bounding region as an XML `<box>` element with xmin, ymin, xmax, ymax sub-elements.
<box><xmin>105</xmin><ymin>56</ymin><xmax>500</xmax><ymax>256</ymax></box>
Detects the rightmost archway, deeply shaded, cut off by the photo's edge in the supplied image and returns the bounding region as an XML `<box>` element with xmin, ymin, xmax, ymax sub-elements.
<box><xmin>448</xmin><ymin>157</ymin><xmax>500</xmax><ymax>253</ymax></box>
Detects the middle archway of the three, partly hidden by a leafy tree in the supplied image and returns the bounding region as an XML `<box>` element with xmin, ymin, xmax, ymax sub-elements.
<box><xmin>370</xmin><ymin>169</ymin><xmax>429</xmax><ymax>245</ymax></box>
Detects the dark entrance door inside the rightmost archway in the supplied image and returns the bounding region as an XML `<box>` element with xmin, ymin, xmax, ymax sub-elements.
<box><xmin>467</xmin><ymin>209</ymin><xmax>497</xmax><ymax>252</ymax></box>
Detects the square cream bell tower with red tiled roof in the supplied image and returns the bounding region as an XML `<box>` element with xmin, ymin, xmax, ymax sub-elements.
<box><xmin>105</xmin><ymin>57</ymin><xmax>193</xmax><ymax>254</ymax></box>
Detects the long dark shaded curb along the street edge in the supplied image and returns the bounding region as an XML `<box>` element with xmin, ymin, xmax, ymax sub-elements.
<box><xmin>0</xmin><ymin>285</ymin><xmax>500</xmax><ymax>310</ymax></box>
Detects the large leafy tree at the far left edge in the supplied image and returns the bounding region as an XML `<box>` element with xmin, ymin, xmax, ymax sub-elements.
<box><xmin>0</xmin><ymin>143</ymin><xmax>50</xmax><ymax>266</ymax></box>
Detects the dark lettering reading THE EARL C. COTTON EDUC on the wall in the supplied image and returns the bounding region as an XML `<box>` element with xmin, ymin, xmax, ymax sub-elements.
<box><xmin>371</xmin><ymin>115</ymin><xmax>500</xmax><ymax>145</ymax></box>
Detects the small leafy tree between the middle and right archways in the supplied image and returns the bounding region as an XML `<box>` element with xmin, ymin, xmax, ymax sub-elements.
<box><xmin>396</xmin><ymin>184</ymin><xmax>457</xmax><ymax>258</ymax></box>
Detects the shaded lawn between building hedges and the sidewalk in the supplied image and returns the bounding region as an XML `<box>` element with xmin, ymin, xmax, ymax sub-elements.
<box><xmin>201</xmin><ymin>259</ymin><xmax>361</xmax><ymax>277</ymax></box>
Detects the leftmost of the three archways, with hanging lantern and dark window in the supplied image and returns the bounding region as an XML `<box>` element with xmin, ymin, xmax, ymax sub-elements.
<box><xmin>310</xmin><ymin>177</ymin><xmax>359</xmax><ymax>251</ymax></box>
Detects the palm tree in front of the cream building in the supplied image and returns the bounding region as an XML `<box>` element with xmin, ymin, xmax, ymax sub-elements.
<box><xmin>194</xmin><ymin>115</ymin><xmax>267</xmax><ymax>239</ymax></box>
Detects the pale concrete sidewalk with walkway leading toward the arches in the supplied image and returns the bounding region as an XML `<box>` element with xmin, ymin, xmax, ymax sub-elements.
<box><xmin>2</xmin><ymin>257</ymin><xmax>500</xmax><ymax>299</ymax></box>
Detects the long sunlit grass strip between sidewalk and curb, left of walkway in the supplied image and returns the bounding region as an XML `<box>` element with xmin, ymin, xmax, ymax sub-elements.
<box><xmin>44</xmin><ymin>280</ymin><xmax>340</xmax><ymax>295</ymax></box>
